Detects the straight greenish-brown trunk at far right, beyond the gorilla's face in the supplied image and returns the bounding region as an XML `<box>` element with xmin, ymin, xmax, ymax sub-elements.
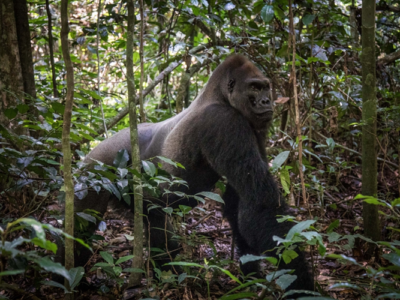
<box><xmin>361</xmin><ymin>0</ymin><xmax>381</xmax><ymax>244</ymax></box>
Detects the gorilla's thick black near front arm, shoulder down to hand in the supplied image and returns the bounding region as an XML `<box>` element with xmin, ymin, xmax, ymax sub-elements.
<box><xmin>200</xmin><ymin>105</ymin><xmax>314</xmax><ymax>290</ymax></box>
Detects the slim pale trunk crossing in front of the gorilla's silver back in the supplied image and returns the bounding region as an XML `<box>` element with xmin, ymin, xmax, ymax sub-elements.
<box><xmin>126</xmin><ymin>0</ymin><xmax>143</xmax><ymax>286</ymax></box>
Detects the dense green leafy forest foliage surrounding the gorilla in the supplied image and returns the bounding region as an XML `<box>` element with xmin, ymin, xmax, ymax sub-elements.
<box><xmin>0</xmin><ymin>0</ymin><xmax>400</xmax><ymax>299</ymax></box>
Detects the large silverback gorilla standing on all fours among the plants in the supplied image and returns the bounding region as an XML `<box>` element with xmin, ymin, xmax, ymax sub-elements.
<box><xmin>75</xmin><ymin>55</ymin><xmax>313</xmax><ymax>290</ymax></box>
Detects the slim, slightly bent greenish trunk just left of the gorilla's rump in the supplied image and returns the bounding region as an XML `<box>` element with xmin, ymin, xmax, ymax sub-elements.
<box><xmin>61</xmin><ymin>0</ymin><xmax>74</xmax><ymax>300</ymax></box>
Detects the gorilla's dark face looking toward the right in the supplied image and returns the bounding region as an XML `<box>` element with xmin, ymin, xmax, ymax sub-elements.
<box><xmin>230</xmin><ymin>76</ymin><xmax>273</xmax><ymax>129</ymax></box>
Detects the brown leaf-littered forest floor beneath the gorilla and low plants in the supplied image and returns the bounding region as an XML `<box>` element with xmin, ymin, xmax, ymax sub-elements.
<box><xmin>0</xmin><ymin>166</ymin><xmax>394</xmax><ymax>300</ymax></box>
